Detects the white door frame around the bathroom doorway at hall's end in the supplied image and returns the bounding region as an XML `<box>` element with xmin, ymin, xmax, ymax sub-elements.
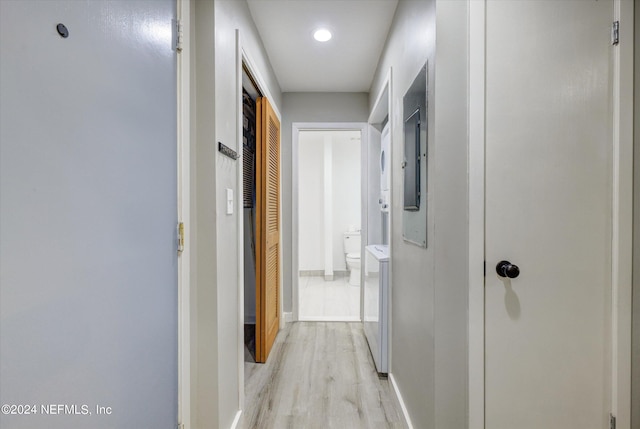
<box><xmin>291</xmin><ymin>122</ymin><xmax>369</xmax><ymax>321</ymax></box>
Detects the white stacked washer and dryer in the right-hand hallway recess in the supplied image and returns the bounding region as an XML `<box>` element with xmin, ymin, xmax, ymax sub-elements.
<box><xmin>363</xmin><ymin>123</ymin><xmax>391</xmax><ymax>373</ymax></box>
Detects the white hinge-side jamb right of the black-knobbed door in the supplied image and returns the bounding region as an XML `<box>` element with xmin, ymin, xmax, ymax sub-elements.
<box><xmin>611</xmin><ymin>0</ymin><xmax>634</xmax><ymax>429</ymax></box>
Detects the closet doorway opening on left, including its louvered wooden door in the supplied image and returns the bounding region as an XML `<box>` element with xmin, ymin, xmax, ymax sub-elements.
<box><xmin>242</xmin><ymin>64</ymin><xmax>281</xmax><ymax>362</ymax></box>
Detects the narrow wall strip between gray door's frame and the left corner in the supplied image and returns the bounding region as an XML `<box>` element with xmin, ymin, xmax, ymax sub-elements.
<box><xmin>188</xmin><ymin>2</ymin><xmax>219</xmax><ymax>427</ymax></box>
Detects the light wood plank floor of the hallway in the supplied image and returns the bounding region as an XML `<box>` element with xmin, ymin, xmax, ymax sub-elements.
<box><xmin>240</xmin><ymin>322</ymin><xmax>406</xmax><ymax>429</ymax></box>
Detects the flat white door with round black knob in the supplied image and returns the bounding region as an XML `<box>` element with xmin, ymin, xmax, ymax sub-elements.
<box><xmin>485</xmin><ymin>0</ymin><xmax>613</xmax><ymax>429</ymax></box>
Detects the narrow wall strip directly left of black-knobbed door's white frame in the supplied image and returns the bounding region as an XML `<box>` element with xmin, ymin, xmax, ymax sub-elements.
<box><xmin>431</xmin><ymin>0</ymin><xmax>469</xmax><ymax>428</ymax></box>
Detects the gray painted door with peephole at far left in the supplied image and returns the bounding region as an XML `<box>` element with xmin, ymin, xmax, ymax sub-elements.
<box><xmin>0</xmin><ymin>0</ymin><xmax>178</xmax><ymax>429</ymax></box>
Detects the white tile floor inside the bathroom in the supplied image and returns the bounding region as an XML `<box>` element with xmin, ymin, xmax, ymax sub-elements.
<box><xmin>298</xmin><ymin>276</ymin><xmax>360</xmax><ymax>322</ymax></box>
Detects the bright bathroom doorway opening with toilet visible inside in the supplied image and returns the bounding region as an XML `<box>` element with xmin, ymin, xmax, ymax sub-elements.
<box><xmin>294</xmin><ymin>129</ymin><xmax>362</xmax><ymax>321</ymax></box>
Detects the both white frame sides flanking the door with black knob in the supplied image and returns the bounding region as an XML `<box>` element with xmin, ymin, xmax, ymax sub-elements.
<box><xmin>468</xmin><ymin>0</ymin><xmax>634</xmax><ymax>429</ymax></box>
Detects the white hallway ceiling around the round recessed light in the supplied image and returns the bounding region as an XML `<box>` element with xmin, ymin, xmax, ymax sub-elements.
<box><xmin>248</xmin><ymin>0</ymin><xmax>398</xmax><ymax>92</ymax></box>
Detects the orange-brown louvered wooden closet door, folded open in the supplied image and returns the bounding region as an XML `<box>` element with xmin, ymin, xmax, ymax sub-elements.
<box><xmin>256</xmin><ymin>97</ymin><xmax>280</xmax><ymax>362</ymax></box>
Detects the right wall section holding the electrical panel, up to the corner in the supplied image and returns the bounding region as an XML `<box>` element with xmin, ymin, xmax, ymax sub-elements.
<box><xmin>369</xmin><ymin>0</ymin><xmax>437</xmax><ymax>428</ymax></box>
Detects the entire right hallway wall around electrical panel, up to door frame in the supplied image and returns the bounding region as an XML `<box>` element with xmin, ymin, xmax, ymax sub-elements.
<box><xmin>370</xmin><ymin>0</ymin><xmax>468</xmax><ymax>428</ymax></box>
